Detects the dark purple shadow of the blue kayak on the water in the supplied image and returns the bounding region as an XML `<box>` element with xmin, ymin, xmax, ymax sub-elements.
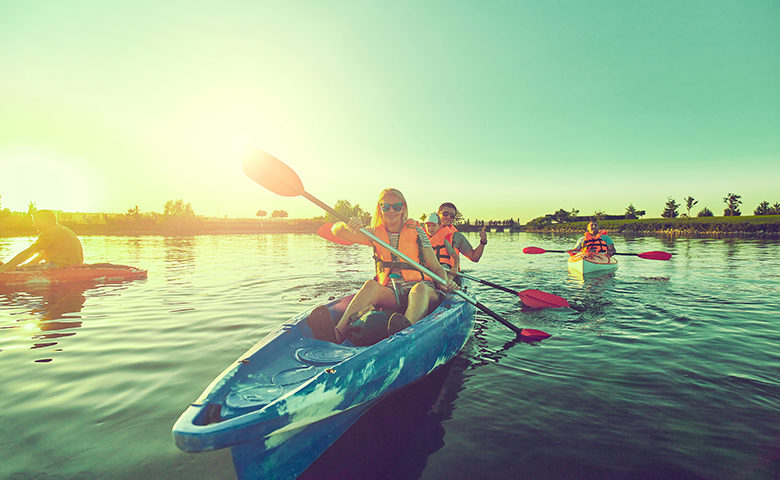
<box><xmin>299</xmin><ymin>352</ymin><xmax>471</xmax><ymax>480</ymax></box>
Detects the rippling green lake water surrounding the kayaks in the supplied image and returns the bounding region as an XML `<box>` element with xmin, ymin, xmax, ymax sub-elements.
<box><xmin>0</xmin><ymin>233</ymin><xmax>780</xmax><ymax>480</ymax></box>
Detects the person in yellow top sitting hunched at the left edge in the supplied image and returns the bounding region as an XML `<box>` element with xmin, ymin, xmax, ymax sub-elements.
<box><xmin>0</xmin><ymin>210</ymin><xmax>84</xmax><ymax>273</ymax></box>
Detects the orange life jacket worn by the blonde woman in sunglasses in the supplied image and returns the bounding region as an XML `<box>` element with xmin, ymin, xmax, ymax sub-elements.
<box><xmin>372</xmin><ymin>218</ymin><xmax>430</xmax><ymax>285</ymax></box>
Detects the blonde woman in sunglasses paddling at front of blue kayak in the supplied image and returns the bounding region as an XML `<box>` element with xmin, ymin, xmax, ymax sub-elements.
<box><xmin>309</xmin><ymin>188</ymin><xmax>457</xmax><ymax>343</ymax></box>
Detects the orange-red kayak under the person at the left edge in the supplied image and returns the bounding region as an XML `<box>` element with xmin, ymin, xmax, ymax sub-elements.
<box><xmin>0</xmin><ymin>263</ymin><xmax>147</xmax><ymax>290</ymax></box>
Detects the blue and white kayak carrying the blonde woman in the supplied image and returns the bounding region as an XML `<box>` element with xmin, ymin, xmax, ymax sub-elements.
<box><xmin>173</xmin><ymin>280</ymin><xmax>474</xmax><ymax>480</ymax></box>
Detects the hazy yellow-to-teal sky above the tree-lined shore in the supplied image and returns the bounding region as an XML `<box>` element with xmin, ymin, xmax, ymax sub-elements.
<box><xmin>0</xmin><ymin>0</ymin><xmax>780</xmax><ymax>221</ymax></box>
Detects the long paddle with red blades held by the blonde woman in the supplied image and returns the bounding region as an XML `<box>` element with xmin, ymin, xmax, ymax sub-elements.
<box><xmin>244</xmin><ymin>150</ymin><xmax>550</xmax><ymax>341</ymax></box>
